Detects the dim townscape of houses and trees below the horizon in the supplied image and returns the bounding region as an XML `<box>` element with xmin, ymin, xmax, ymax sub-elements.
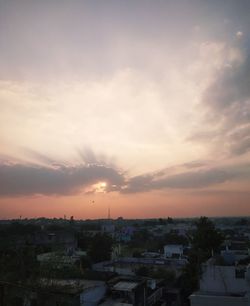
<box><xmin>0</xmin><ymin>216</ymin><xmax>250</xmax><ymax>306</ymax></box>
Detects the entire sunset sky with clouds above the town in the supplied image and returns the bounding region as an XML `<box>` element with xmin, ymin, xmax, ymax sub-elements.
<box><xmin>0</xmin><ymin>0</ymin><xmax>250</xmax><ymax>219</ymax></box>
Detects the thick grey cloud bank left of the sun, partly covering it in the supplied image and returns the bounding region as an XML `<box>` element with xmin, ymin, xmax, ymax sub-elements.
<box><xmin>0</xmin><ymin>164</ymin><xmax>124</xmax><ymax>196</ymax></box>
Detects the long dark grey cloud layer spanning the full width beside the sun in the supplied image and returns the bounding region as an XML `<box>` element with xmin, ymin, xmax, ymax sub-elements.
<box><xmin>0</xmin><ymin>163</ymin><xmax>250</xmax><ymax>196</ymax></box>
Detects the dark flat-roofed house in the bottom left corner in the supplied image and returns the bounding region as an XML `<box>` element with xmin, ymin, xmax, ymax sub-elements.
<box><xmin>0</xmin><ymin>279</ymin><xmax>107</xmax><ymax>306</ymax></box>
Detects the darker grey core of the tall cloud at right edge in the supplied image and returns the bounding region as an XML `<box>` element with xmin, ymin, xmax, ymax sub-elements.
<box><xmin>203</xmin><ymin>55</ymin><xmax>250</xmax><ymax>155</ymax></box>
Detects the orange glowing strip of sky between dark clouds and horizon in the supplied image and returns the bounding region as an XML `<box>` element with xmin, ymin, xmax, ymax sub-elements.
<box><xmin>0</xmin><ymin>189</ymin><xmax>250</xmax><ymax>219</ymax></box>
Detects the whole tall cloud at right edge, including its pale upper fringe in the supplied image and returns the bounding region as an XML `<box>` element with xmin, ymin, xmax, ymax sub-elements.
<box><xmin>187</xmin><ymin>32</ymin><xmax>250</xmax><ymax>156</ymax></box>
